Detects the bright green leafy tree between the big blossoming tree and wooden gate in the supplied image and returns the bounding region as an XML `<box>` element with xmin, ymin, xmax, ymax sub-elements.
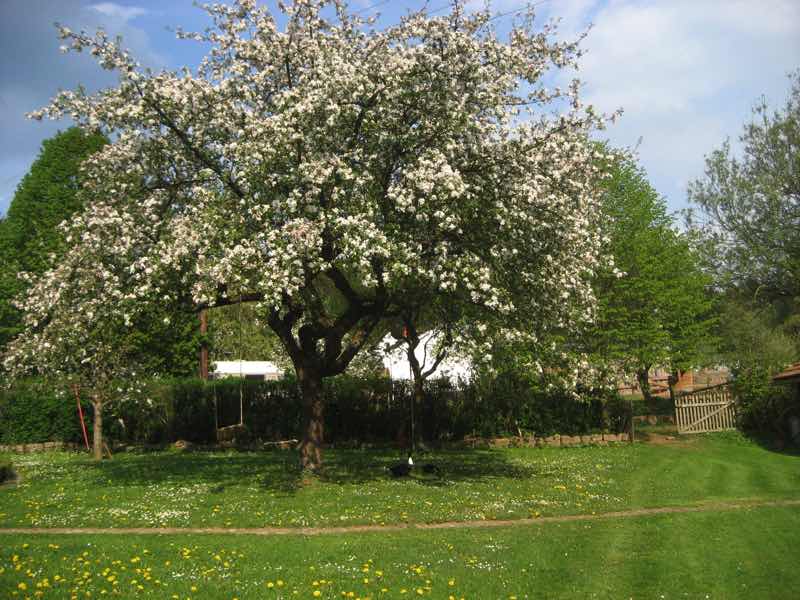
<box><xmin>591</xmin><ymin>157</ymin><xmax>713</xmax><ymax>400</ymax></box>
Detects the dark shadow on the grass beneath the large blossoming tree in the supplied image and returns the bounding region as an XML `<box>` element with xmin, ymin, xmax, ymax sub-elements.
<box><xmin>76</xmin><ymin>449</ymin><xmax>546</xmax><ymax>495</ymax></box>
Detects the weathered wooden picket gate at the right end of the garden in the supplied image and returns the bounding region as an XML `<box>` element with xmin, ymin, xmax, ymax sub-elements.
<box><xmin>675</xmin><ymin>383</ymin><xmax>736</xmax><ymax>433</ymax></box>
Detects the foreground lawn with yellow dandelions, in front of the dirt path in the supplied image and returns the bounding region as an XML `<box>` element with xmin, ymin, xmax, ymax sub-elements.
<box><xmin>0</xmin><ymin>507</ymin><xmax>800</xmax><ymax>600</ymax></box>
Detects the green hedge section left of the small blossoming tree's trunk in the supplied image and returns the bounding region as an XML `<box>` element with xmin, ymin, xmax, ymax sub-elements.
<box><xmin>0</xmin><ymin>379</ymin><xmax>92</xmax><ymax>444</ymax></box>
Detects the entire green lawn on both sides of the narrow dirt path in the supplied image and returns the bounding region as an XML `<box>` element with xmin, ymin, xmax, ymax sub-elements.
<box><xmin>0</xmin><ymin>434</ymin><xmax>800</xmax><ymax>600</ymax></box>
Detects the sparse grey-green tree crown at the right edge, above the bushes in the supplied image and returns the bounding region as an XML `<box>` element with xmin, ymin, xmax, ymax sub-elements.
<box><xmin>689</xmin><ymin>71</ymin><xmax>800</xmax><ymax>317</ymax></box>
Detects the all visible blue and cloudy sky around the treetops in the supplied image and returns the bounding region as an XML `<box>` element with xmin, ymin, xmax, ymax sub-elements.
<box><xmin>0</xmin><ymin>0</ymin><xmax>800</xmax><ymax>213</ymax></box>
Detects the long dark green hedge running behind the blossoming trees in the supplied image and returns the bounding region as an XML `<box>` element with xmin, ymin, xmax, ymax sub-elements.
<box><xmin>0</xmin><ymin>375</ymin><xmax>630</xmax><ymax>444</ymax></box>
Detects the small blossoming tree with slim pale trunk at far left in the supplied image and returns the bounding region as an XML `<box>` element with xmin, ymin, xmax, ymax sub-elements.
<box><xmin>3</xmin><ymin>212</ymin><xmax>141</xmax><ymax>460</ymax></box>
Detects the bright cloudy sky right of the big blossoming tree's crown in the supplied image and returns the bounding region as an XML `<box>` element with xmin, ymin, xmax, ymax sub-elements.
<box><xmin>546</xmin><ymin>0</ymin><xmax>800</xmax><ymax>208</ymax></box>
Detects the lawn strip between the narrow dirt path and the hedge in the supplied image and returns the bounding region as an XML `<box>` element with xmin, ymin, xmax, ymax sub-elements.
<box><xmin>0</xmin><ymin>434</ymin><xmax>800</xmax><ymax>528</ymax></box>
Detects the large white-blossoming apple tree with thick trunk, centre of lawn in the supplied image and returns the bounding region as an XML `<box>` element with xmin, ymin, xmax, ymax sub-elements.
<box><xmin>7</xmin><ymin>0</ymin><xmax>607</xmax><ymax>470</ymax></box>
